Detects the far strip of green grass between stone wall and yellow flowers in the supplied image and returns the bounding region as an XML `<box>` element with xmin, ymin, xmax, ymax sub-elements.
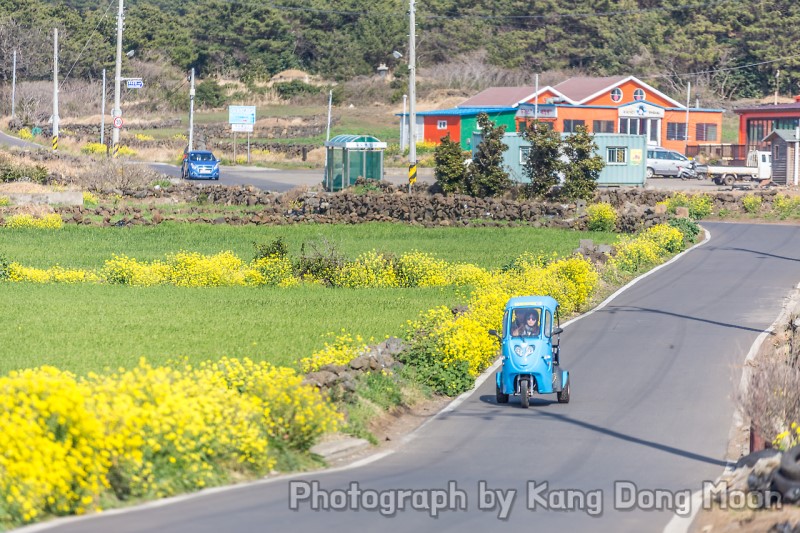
<box><xmin>0</xmin><ymin>223</ymin><xmax>616</xmax><ymax>268</ymax></box>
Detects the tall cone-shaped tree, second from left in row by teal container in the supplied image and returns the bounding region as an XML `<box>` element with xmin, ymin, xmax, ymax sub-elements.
<box><xmin>466</xmin><ymin>113</ymin><xmax>511</xmax><ymax>197</ymax></box>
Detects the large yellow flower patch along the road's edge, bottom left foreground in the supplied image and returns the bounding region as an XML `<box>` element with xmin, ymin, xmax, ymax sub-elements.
<box><xmin>0</xmin><ymin>359</ymin><xmax>342</xmax><ymax>527</ymax></box>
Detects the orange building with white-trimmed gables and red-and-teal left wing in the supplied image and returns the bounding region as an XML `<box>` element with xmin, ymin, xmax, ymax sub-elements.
<box><xmin>412</xmin><ymin>76</ymin><xmax>722</xmax><ymax>152</ymax></box>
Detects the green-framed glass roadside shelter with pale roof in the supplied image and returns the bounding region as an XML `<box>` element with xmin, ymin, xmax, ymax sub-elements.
<box><xmin>322</xmin><ymin>135</ymin><xmax>386</xmax><ymax>192</ymax></box>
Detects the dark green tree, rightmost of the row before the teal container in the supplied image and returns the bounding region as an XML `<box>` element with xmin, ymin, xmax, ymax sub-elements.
<box><xmin>561</xmin><ymin>126</ymin><xmax>605</xmax><ymax>200</ymax></box>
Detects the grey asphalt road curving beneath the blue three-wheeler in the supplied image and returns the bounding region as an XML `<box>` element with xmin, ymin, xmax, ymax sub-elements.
<box><xmin>32</xmin><ymin>224</ymin><xmax>800</xmax><ymax>533</ymax></box>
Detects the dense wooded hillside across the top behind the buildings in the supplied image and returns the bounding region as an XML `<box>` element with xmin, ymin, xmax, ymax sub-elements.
<box><xmin>0</xmin><ymin>0</ymin><xmax>800</xmax><ymax>101</ymax></box>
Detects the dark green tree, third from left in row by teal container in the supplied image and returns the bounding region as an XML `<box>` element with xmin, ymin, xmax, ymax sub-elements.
<box><xmin>522</xmin><ymin>120</ymin><xmax>564</xmax><ymax>197</ymax></box>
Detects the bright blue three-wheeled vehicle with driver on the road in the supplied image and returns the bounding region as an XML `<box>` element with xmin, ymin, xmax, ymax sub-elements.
<box><xmin>489</xmin><ymin>296</ymin><xmax>570</xmax><ymax>409</ymax></box>
